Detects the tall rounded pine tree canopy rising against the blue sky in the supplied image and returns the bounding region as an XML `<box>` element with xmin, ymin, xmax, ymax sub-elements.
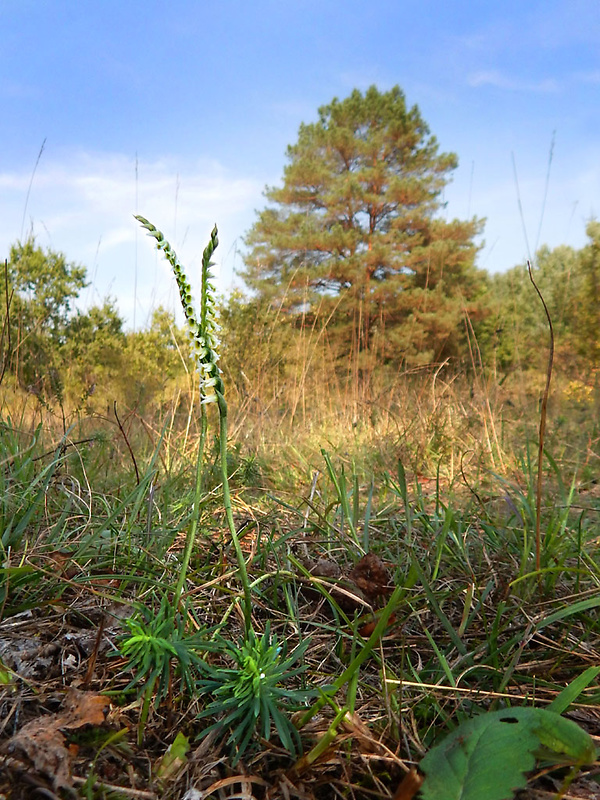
<box><xmin>242</xmin><ymin>86</ymin><xmax>483</xmax><ymax>363</ymax></box>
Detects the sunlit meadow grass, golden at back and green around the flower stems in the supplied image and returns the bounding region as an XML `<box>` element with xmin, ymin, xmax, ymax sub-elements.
<box><xmin>0</xmin><ymin>348</ymin><xmax>600</xmax><ymax>797</ymax></box>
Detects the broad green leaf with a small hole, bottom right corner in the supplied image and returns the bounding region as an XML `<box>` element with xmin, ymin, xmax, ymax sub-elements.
<box><xmin>421</xmin><ymin>708</ymin><xmax>596</xmax><ymax>800</ymax></box>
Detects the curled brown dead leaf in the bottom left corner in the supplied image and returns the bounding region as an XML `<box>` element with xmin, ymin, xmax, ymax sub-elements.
<box><xmin>8</xmin><ymin>688</ymin><xmax>109</xmax><ymax>789</ymax></box>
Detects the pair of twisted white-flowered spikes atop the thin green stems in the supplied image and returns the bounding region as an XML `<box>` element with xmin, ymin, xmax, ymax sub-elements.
<box><xmin>135</xmin><ymin>215</ymin><xmax>223</xmax><ymax>403</ymax></box>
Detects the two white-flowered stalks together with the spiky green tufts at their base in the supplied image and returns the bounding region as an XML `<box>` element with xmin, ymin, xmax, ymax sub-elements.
<box><xmin>131</xmin><ymin>216</ymin><xmax>308</xmax><ymax>762</ymax></box>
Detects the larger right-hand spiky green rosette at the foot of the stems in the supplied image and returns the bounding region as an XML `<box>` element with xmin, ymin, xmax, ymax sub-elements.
<box><xmin>198</xmin><ymin>625</ymin><xmax>310</xmax><ymax>765</ymax></box>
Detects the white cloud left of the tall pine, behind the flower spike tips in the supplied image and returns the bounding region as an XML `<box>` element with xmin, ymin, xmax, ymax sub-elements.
<box><xmin>0</xmin><ymin>153</ymin><xmax>263</xmax><ymax>325</ymax></box>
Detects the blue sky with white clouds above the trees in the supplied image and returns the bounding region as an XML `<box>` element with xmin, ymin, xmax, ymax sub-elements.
<box><xmin>0</xmin><ymin>0</ymin><xmax>600</xmax><ymax>328</ymax></box>
